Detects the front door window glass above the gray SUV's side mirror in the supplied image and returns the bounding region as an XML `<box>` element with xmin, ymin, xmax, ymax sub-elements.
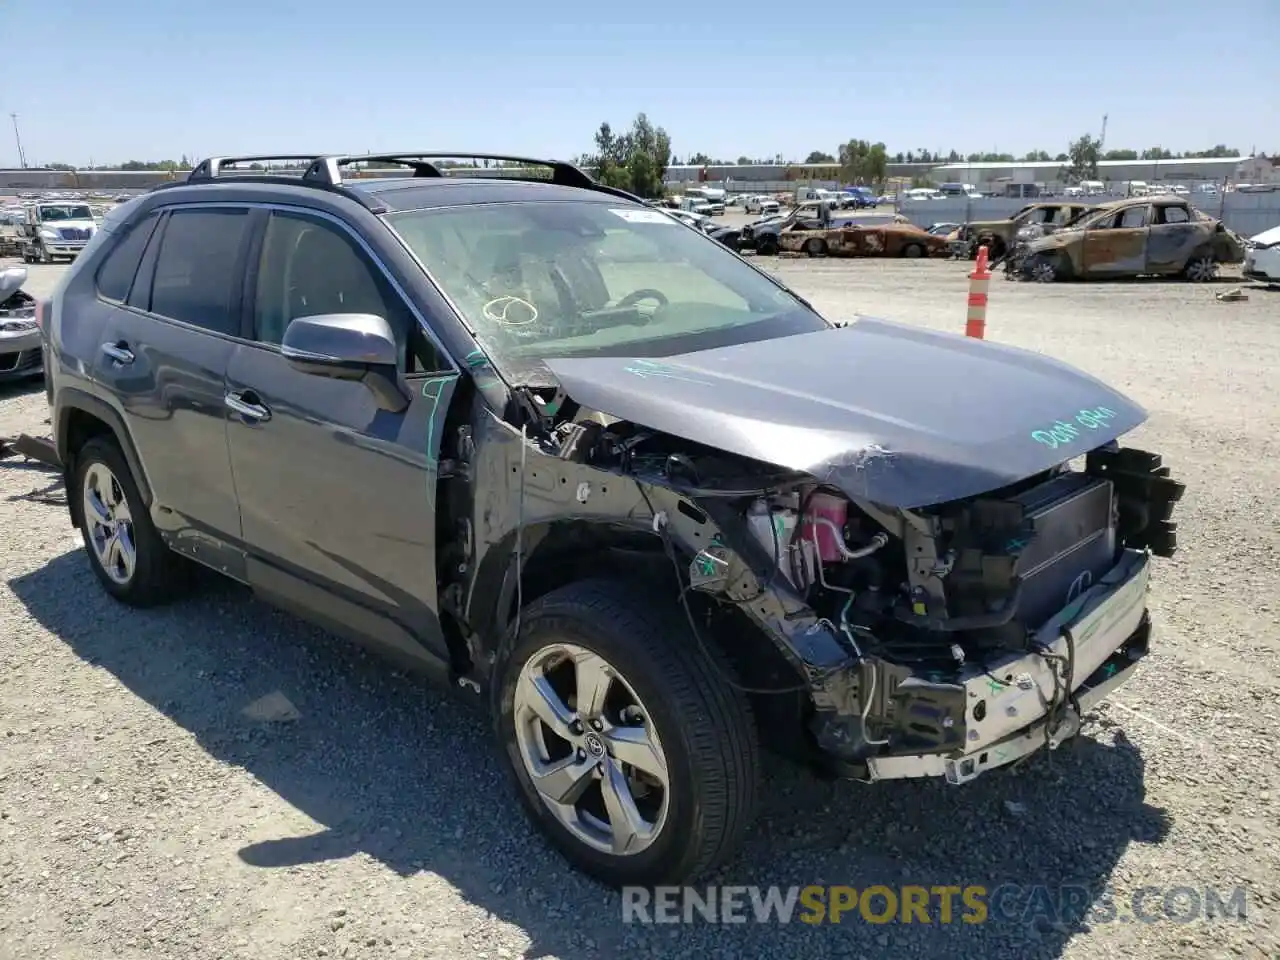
<box><xmin>253</xmin><ymin>211</ymin><xmax>448</xmax><ymax>374</ymax></box>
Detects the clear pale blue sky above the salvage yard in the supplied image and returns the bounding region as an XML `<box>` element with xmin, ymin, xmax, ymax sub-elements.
<box><xmin>0</xmin><ymin>0</ymin><xmax>1280</xmax><ymax>166</ymax></box>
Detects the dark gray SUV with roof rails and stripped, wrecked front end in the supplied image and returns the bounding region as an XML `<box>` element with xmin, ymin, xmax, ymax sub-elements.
<box><xmin>41</xmin><ymin>154</ymin><xmax>1183</xmax><ymax>884</ymax></box>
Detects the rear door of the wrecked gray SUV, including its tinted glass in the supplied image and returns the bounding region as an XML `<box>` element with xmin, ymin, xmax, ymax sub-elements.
<box><xmin>93</xmin><ymin>205</ymin><xmax>250</xmax><ymax>563</ymax></box>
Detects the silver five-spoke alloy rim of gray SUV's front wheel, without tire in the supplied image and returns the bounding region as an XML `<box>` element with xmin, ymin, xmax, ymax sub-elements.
<box><xmin>513</xmin><ymin>643</ymin><xmax>671</xmax><ymax>856</ymax></box>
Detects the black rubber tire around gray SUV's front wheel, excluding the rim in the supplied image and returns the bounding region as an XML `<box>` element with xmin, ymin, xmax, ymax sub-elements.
<box><xmin>493</xmin><ymin>580</ymin><xmax>760</xmax><ymax>887</ymax></box>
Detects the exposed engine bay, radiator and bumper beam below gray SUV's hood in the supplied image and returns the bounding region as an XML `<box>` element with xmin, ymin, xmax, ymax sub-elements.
<box><xmin>483</xmin><ymin>391</ymin><xmax>1183</xmax><ymax>783</ymax></box>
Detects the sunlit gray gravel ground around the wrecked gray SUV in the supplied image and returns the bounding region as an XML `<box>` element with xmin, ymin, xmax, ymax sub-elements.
<box><xmin>0</xmin><ymin>260</ymin><xmax>1280</xmax><ymax>960</ymax></box>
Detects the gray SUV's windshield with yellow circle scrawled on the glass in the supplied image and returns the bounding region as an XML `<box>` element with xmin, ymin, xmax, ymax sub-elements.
<box><xmin>387</xmin><ymin>201</ymin><xmax>827</xmax><ymax>367</ymax></box>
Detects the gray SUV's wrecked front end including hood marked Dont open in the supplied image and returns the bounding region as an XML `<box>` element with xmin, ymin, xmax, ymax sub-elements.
<box><xmin>455</xmin><ymin>317</ymin><xmax>1183</xmax><ymax>782</ymax></box>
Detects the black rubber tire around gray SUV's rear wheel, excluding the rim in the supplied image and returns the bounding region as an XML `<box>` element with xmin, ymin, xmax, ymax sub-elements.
<box><xmin>67</xmin><ymin>436</ymin><xmax>191</xmax><ymax>607</ymax></box>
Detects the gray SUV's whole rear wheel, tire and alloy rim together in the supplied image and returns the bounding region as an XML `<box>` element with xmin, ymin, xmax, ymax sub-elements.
<box><xmin>69</xmin><ymin>436</ymin><xmax>188</xmax><ymax>607</ymax></box>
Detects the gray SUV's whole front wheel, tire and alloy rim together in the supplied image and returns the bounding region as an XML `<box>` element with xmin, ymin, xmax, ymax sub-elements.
<box><xmin>494</xmin><ymin>580</ymin><xmax>759</xmax><ymax>887</ymax></box>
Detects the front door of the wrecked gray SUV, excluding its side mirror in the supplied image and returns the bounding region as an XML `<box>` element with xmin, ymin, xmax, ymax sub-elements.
<box><xmin>227</xmin><ymin>210</ymin><xmax>457</xmax><ymax>667</ymax></box>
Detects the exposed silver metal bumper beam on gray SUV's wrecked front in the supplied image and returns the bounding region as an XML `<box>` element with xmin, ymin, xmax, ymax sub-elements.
<box><xmin>849</xmin><ymin>550</ymin><xmax>1151</xmax><ymax>783</ymax></box>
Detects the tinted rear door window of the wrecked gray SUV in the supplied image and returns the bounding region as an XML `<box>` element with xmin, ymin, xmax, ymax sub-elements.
<box><xmin>151</xmin><ymin>210</ymin><xmax>248</xmax><ymax>337</ymax></box>
